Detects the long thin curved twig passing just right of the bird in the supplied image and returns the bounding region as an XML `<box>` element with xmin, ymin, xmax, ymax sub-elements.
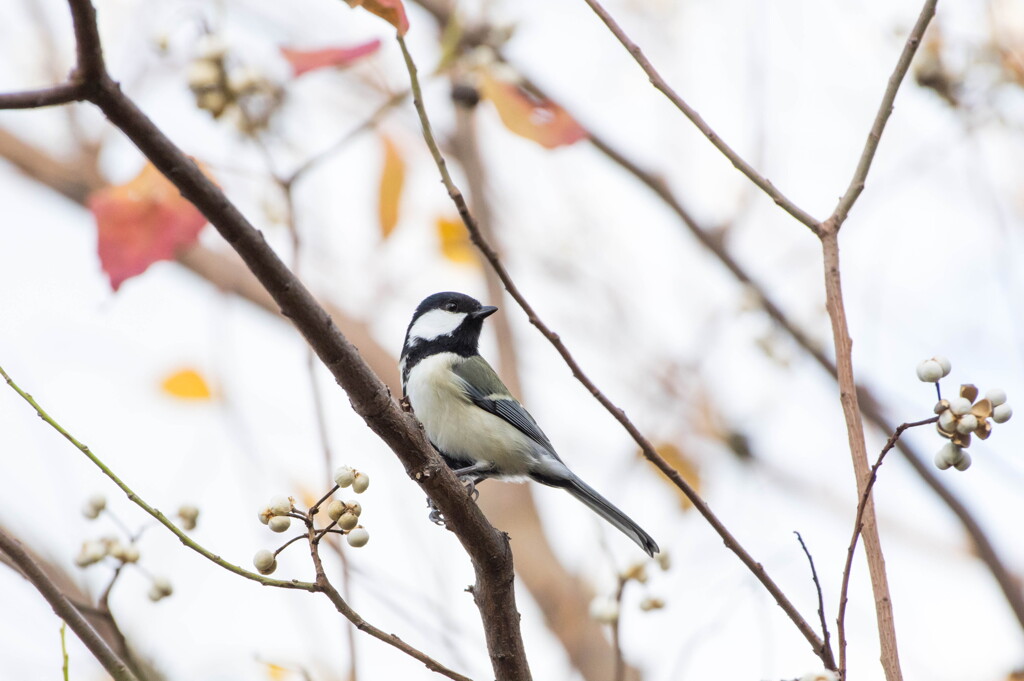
<box><xmin>397</xmin><ymin>36</ymin><xmax>822</xmax><ymax>654</ymax></box>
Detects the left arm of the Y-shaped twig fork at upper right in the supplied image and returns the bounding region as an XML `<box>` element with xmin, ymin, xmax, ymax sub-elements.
<box><xmin>585</xmin><ymin>0</ymin><xmax>820</xmax><ymax>233</ymax></box>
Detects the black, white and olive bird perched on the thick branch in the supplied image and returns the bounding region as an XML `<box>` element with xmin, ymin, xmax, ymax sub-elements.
<box><xmin>398</xmin><ymin>291</ymin><xmax>658</xmax><ymax>556</ymax></box>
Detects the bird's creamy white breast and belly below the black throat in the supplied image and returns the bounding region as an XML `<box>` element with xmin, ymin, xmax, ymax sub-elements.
<box><xmin>406</xmin><ymin>354</ymin><xmax>539</xmax><ymax>477</ymax></box>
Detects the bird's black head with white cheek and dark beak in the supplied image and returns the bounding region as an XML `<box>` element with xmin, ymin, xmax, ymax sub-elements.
<box><xmin>401</xmin><ymin>291</ymin><xmax>498</xmax><ymax>383</ymax></box>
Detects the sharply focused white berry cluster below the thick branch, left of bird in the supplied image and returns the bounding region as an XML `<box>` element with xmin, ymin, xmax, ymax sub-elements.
<box><xmin>253</xmin><ymin>466</ymin><xmax>370</xmax><ymax>574</ymax></box>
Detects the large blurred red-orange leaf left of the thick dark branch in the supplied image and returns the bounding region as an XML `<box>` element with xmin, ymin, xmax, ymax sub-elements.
<box><xmin>88</xmin><ymin>163</ymin><xmax>206</xmax><ymax>291</ymax></box>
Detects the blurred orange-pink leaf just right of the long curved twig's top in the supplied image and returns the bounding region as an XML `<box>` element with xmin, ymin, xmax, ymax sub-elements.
<box><xmin>480</xmin><ymin>74</ymin><xmax>587</xmax><ymax>148</ymax></box>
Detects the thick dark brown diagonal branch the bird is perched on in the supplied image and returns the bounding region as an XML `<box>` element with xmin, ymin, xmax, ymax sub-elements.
<box><xmin>48</xmin><ymin>0</ymin><xmax>530</xmax><ymax>681</ymax></box>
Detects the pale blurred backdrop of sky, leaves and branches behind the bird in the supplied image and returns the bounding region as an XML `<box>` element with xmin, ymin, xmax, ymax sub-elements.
<box><xmin>0</xmin><ymin>0</ymin><xmax>1024</xmax><ymax>681</ymax></box>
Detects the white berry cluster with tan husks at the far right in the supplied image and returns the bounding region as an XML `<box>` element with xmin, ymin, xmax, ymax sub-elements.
<box><xmin>918</xmin><ymin>356</ymin><xmax>1014</xmax><ymax>471</ymax></box>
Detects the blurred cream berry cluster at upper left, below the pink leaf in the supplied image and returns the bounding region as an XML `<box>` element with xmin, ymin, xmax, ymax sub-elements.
<box><xmin>187</xmin><ymin>35</ymin><xmax>284</xmax><ymax>134</ymax></box>
